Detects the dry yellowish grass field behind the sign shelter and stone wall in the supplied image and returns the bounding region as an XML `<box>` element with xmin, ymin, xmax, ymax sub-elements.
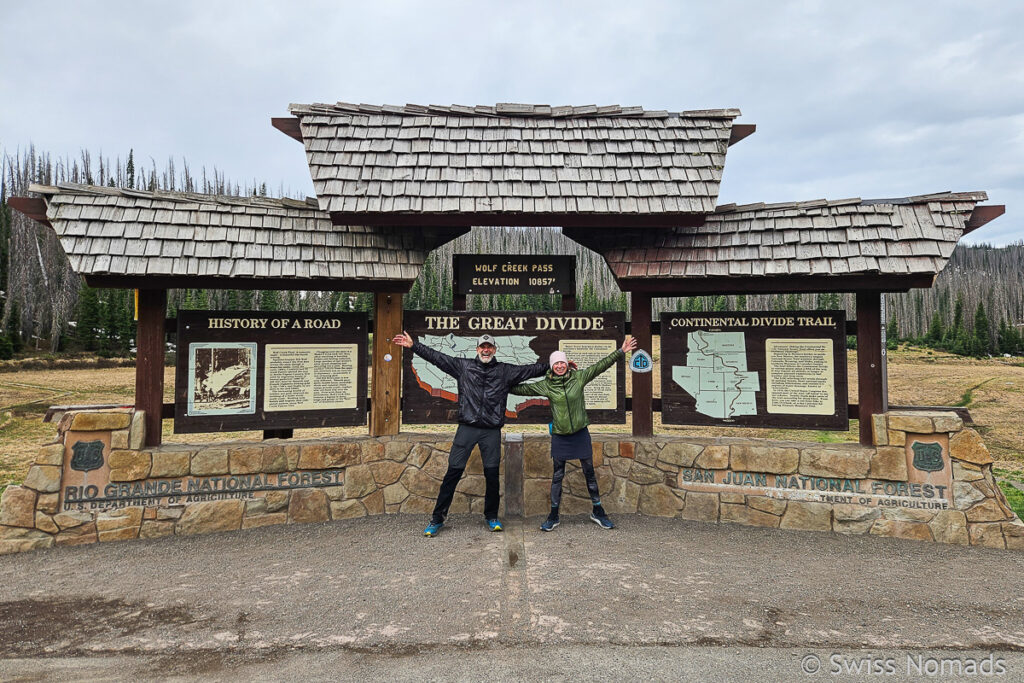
<box><xmin>0</xmin><ymin>342</ymin><xmax>1024</xmax><ymax>488</ymax></box>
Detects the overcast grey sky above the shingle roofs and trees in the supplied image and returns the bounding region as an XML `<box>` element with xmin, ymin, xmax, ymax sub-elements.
<box><xmin>0</xmin><ymin>0</ymin><xmax>1024</xmax><ymax>245</ymax></box>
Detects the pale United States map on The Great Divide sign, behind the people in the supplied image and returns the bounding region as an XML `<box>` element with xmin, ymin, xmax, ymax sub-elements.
<box><xmin>413</xmin><ymin>334</ymin><xmax>548</xmax><ymax>418</ymax></box>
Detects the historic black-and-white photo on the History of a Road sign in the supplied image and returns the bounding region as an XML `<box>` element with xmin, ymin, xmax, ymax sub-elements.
<box><xmin>188</xmin><ymin>343</ymin><xmax>256</xmax><ymax>415</ymax></box>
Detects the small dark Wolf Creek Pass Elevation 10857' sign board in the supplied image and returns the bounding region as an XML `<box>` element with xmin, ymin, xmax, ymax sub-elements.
<box><xmin>452</xmin><ymin>254</ymin><xmax>575</xmax><ymax>296</ymax></box>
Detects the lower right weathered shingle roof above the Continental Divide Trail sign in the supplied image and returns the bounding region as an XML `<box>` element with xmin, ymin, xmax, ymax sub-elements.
<box><xmin>570</xmin><ymin>193</ymin><xmax>987</xmax><ymax>280</ymax></box>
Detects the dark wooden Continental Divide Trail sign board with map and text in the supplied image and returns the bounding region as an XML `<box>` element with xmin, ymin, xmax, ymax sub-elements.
<box><xmin>662</xmin><ymin>310</ymin><xmax>850</xmax><ymax>431</ymax></box>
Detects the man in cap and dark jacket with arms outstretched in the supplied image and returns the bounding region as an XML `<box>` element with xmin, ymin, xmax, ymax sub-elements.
<box><xmin>391</xmin><ymin>332</ymin><xmax>548</xmax><ymax>537</ymax></box>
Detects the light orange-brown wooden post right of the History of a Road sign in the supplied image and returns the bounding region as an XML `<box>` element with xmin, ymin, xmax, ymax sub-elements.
<box><xmin>370</xmin><ymin>292</ymin><xmax>402</xmax><ymax>436</ymax></box>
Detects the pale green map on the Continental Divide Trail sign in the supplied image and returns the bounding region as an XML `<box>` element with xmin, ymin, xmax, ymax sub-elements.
<box><xmin>672</xmin><ymin>332</ymin><xmax>761</xmax><ymax>419</ymax></box>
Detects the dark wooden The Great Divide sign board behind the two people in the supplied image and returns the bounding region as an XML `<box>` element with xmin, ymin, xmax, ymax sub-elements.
<box><xmin>395</xmin><ymin>310</ymin><xmax>626</xmax><ymax>424</ymax></box>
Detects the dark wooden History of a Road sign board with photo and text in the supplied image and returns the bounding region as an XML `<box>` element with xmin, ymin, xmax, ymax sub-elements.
<box><xmin>174</xmin><ymin>310</ymin><xmax>368</xmax><ymax>433</ymax></box>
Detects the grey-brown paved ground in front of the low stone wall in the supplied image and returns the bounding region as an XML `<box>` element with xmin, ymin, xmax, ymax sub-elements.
<box><xmin>0</xmin><ymin>516</ymin><xmax>1024</xmax><ymax>680</ymax></box>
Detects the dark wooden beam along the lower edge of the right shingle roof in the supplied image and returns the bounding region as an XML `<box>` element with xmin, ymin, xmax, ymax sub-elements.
<box><xmin>615</xmin><ymin>273</ymin><xmax>936</xmax><ymax>296</ymax></box>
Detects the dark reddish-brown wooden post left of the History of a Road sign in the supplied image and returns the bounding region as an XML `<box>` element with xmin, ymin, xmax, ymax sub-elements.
<box><xmin>135</xmin><ymin>290</ymin><xmax>167</xmax><ymax>446</ymax></box>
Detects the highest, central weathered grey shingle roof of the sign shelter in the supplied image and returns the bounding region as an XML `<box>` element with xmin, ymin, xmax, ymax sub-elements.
<box><xmin>289</xmin><ymin>102</ymin><xmax>739</xmax><ymax>223</ymax></box>
